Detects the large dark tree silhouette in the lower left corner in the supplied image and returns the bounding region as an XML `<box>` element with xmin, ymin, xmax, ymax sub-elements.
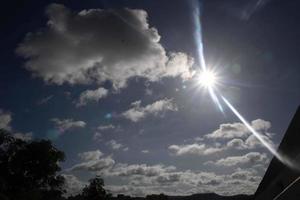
<box><xmin>0</xmin><ymin>130</ymin><xmax>65</xmax><ymax>200</ymax></box>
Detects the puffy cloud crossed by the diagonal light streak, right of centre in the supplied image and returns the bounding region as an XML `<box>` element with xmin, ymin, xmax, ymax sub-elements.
<box><xmin>205</xmin><ymin>119</ymin><xmax>271</xmax><ymax>139</ymax></box>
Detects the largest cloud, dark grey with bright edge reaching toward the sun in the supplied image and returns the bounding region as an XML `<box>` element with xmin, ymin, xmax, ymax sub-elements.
<box><xmin>16</xmin><ymin>4</ymin><xmax>193</xmax><ymax>88</ymax></box>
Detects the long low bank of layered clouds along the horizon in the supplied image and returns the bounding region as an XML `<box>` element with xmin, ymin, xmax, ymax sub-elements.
<box><xmin>69</xmin><ymin>150</ymin><xmax>261</xmax><ymax>196</ymax></box>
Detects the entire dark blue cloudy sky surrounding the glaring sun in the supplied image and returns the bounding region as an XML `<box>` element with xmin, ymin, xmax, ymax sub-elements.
<box><xmin>0</xmin><ymin>0</ymin><xmax>300</xmax><ymax>196</ymax></box>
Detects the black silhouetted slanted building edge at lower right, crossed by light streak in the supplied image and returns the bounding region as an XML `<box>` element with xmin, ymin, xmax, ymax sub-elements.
<box><xmin>255</xmin><ymin>107</ymin><xmax>300</xmax><ymax>200</ymax></box>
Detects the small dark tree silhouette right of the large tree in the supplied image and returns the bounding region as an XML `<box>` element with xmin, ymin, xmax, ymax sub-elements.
<box><xmin>82</xmin><ymin>176</ymin><xmax>108</xmax><ymax>200</ymax></box>
